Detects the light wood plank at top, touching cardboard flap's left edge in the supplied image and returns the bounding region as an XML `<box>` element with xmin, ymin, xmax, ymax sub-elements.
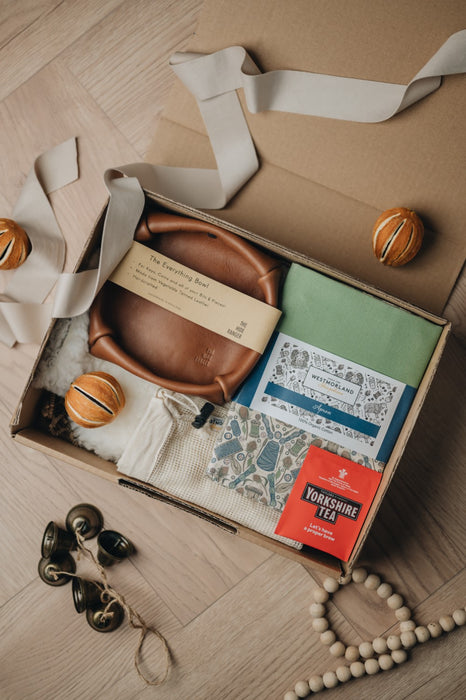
<box><xmin>64</xmin><ymin>0</ymin><xmax>200</xmax><ymax>157</ymax></box>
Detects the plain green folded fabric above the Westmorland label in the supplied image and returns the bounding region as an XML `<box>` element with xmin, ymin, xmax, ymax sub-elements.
<box><xmin>277</xmin><ymin>263</ymin><xmax>442</xmax><ymax>387</ymax></box>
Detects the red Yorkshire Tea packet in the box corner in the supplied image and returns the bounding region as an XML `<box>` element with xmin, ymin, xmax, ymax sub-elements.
<box><xmin>275</xmin><ymin>446</ymin><xmax>382</xmax><ymax>561</ymax></box>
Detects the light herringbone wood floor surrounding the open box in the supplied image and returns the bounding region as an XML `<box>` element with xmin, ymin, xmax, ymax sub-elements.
<box><xmin>0</xmin><ymin>0</ymin><xmax>466</xmax><ymax>700</ymax></box>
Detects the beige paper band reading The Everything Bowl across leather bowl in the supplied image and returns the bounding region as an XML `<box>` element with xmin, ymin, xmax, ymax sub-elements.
<box><xmin>110</xmin><ymin>241</ymin><xmax>281</xmax><ymax>353</ymax></box>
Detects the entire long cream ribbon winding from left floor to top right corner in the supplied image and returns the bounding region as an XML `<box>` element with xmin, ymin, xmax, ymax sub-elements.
<box><xmin>0</xmin><ymin>30</ymin><xmax>466</xmax><ymax>346</ymax></box>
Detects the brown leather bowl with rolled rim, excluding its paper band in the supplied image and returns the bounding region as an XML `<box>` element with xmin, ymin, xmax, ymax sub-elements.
<box><xmin>89</xmin><ymin>212</ymin><xmax>281</xmax><ymax>403</ymax></box>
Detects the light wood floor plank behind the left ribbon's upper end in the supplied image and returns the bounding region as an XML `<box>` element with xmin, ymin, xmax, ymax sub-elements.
<box><xmin>0</xmin><ymin>61</ymin><xmax>138</xmax><ymax>269</ymax></box>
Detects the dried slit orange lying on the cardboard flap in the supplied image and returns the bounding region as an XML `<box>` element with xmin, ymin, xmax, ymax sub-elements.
<box><xmin>372</xmin><ymin>207</ymin><xmax>424</xmax><ymax>267</ymax></box>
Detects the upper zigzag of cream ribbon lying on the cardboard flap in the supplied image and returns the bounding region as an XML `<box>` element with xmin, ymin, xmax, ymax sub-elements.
<box><xmin>120</xmin><ymin>30</ymin><xmax>466</xmax><ymax>209</ymax></box>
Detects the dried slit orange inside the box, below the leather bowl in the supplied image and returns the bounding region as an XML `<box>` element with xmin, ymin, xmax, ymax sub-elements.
<box><xmin>65</xmin><ymin>372</ymin><xmax>125</xmax><ymax>428</ymax></box>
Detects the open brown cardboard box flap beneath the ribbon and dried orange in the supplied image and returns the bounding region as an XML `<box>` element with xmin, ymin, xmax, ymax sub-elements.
<box><xmin>147</xmin><ymin>0</ymin><xmax>466</xmax><ymax>313</ymax></box>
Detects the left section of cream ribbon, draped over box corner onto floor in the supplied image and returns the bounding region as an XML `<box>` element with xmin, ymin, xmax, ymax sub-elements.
<box><xmin>0</xmin><ymin>148</ymin><xmax>144</xmax><ymax>347</ymax></box>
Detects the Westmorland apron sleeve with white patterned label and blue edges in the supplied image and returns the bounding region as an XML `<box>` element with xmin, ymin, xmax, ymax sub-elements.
<box><xmin>234</xmin><ymin>333</ymin><xmax>415</xmax><ymax>469</ymax></box>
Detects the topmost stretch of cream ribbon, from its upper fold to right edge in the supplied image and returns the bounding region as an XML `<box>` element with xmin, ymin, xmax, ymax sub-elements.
<box><xmin>171</xmin><ymin>30</ymin><xmax>466</xmax><ymax>123</ymax></box>
